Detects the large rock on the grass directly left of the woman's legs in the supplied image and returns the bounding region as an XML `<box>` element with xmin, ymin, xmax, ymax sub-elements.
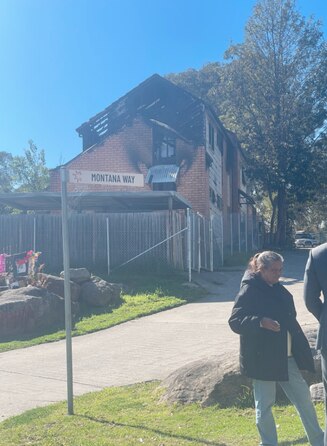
<box><xmin>162</xmin><ymin>352</ymin><xmax>252</xmax><ymax>407</ymax></box>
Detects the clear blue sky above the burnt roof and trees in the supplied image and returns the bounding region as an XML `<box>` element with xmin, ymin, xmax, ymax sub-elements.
<box><xmin>0</xmin><ymin>0</ymin><xmax>327</xmax><ymax>167</ymax></box>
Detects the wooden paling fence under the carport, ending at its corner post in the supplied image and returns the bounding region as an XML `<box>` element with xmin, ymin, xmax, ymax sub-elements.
<box><xmin>0</xmin><ymin>211</ymin><xmax>191</xmax><ymax>272</ymax></box>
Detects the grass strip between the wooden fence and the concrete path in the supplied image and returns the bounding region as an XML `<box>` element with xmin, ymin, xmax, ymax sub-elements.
<box><xmin>0</xmin><ymin>273</ymin><xmax>207</xmax><ymax>352</ymax></box>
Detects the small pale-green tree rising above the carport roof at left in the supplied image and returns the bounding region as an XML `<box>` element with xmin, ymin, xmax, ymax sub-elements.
<box><xmin>12</xmin><ymin>140</ymin><xmax>49</xmax><ymax>192</ymax></box>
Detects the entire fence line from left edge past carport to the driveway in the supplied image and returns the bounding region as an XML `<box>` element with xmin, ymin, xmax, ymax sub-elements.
<box><xmin>0</xmin><ymin>207</ymin><xmax>261</xmax><ymax>272</ymax></box>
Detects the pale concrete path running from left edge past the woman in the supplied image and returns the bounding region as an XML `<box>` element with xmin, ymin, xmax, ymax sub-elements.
<box><xmin>0</xmin><ymin>250</ymin><xmax>317</xmax><ymax>420</ymax></box>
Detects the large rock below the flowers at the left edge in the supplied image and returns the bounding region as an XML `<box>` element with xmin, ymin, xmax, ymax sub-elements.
<box><xmin>0</xmin><ymin>286</ymin><xmax>64</xmax><ymax>339</ymax></box>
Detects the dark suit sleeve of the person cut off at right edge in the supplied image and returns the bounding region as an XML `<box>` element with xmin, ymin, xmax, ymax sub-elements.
<box><xmin>303</xmin><ymin>252</ymin><xmax>323</xmax><ymax>321</ymax></box>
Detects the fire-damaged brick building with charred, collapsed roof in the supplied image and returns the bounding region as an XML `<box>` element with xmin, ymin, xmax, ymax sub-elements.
<box><xmin>50</xmin><ymin>74</ymin><xmax>258</xmax><ymax>262</ymax></box>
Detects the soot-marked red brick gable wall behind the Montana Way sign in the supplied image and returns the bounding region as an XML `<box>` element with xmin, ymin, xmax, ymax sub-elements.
<box><xmin>50</xmin><ymin>119</ymin><xmax>209</xmax><ymax>216</ymax></box>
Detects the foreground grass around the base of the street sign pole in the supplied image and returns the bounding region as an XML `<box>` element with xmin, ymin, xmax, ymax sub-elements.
<box><xmin>0</xmin><ymin>382</ymin><xmax>324</xmax><ymax>446</ymax></box>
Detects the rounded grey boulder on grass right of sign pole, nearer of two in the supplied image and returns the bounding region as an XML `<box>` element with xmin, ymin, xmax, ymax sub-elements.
<box><xmin>80</xmin><ymin>276</ymin><xmax>122</xmax><ymax>307</ymax></box>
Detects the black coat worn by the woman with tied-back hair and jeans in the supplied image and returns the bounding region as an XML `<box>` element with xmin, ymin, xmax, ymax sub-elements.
<box><xmin>228</xmin><ymin>273</ymin><xmax>314</xmax><ymax>381</ymax></box>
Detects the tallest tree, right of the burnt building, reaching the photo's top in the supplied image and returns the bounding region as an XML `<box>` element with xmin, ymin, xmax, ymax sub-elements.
<box><xmin>220</xmin><ymin>0</ymin><xmax>327</xmax><ymax>245</ymax></box>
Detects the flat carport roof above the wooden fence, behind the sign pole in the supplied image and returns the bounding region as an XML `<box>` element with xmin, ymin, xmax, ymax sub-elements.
<box><xmin>0</xmin><ymin>191</ymin><xmax>191</xmax><ymax>212</ymax></box>
